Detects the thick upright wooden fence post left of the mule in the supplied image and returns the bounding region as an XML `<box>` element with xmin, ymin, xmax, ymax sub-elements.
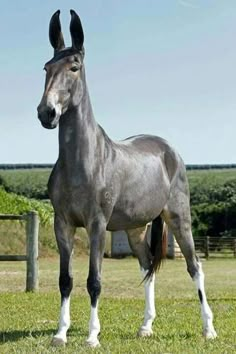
<box><xmin>26</xmin><ymin>211</ymin><xmax>39</xmax><ymax>291</ymax></box>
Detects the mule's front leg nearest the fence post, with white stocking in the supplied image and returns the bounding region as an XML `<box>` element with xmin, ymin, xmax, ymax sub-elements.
<box><xmin>52</xmin><ymin>216</ymin><xmax>75</xmax><ymax>346</ymax></box>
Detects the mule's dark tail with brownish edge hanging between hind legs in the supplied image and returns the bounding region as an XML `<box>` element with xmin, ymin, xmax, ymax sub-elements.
<box><xmin>144</xmin><ymin>215</ymin><xmax>168</xmax><ymax>280</ymax></box>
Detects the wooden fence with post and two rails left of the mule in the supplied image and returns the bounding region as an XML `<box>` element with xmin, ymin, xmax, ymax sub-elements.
<box><xmin>0</xmin><ymin>211</ymin><xmax>39</xmax><ymax>291</ymax></box>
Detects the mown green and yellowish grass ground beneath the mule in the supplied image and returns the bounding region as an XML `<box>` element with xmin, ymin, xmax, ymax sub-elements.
<box><xmin>0</xmin><ymin>256</ymin><xmax>236</xmax><ymax>354</ymax></box>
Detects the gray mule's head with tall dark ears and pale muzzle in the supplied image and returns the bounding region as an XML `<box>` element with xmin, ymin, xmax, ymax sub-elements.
<box><xmin>37</xmin><ymin>10</ymin><xmax>84</xmax><ymax>129</ymax></box>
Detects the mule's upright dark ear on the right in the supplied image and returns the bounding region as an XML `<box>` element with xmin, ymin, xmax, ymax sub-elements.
<box><xmin>70</xmin><ymin>10</ymin><xmax>84</xmax><ymax>51</ymax></box>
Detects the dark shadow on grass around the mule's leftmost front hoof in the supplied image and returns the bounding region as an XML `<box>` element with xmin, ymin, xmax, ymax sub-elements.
<box><xmin>0</xmin><ymin>328</ymin><xmax>87</xmax><ymax>343</ymax></box>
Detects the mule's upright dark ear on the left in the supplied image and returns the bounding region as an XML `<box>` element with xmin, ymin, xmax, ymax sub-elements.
<box><xmin>49</xmin><ymin>10</ymin><xmax>65</xmax><ymax>52</ymax></box>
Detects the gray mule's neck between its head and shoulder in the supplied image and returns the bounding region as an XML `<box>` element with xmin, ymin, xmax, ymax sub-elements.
<box><xmin>59</xmin><ymin>75</ymin><xmax>102</xmax><ymax>174</ymax></box>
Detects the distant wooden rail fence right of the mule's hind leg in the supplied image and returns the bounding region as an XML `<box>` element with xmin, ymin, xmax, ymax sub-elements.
<box><xmin>176</xmin><ymin>236</ymin><xmax>236</xmax><ymax>259</ymax></box>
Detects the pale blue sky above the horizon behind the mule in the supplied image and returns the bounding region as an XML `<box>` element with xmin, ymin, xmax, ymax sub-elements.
<box><xmin>0</xmin><ymin>0</ymin><xmax>236</xmax><ymax>164</ymax></box>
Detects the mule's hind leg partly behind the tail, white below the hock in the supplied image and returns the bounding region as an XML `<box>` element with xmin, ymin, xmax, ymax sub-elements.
<box><xmin>126</xmin><ymin>227</ymin><xmax>156</xmax><ymax>337</ymax></box>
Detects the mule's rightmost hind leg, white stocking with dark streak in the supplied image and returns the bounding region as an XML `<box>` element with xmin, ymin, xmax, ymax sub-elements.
<box><xmin>162</xmin><ymin>189</ymin><xmax>217</xmax><ymax>339</ymax></box>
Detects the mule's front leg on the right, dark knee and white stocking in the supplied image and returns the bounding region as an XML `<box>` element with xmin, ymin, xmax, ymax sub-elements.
<box><xmin>86</xmin><ymin>217</ymin><xmax>106</xmax><ymax>348</ymax></box>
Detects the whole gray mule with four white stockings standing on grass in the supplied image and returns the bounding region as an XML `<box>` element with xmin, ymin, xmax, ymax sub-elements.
<box><xmin>38</xmin><ymin>10</ymin><xmax>216</xmax><ymax>347</ymax></box>
